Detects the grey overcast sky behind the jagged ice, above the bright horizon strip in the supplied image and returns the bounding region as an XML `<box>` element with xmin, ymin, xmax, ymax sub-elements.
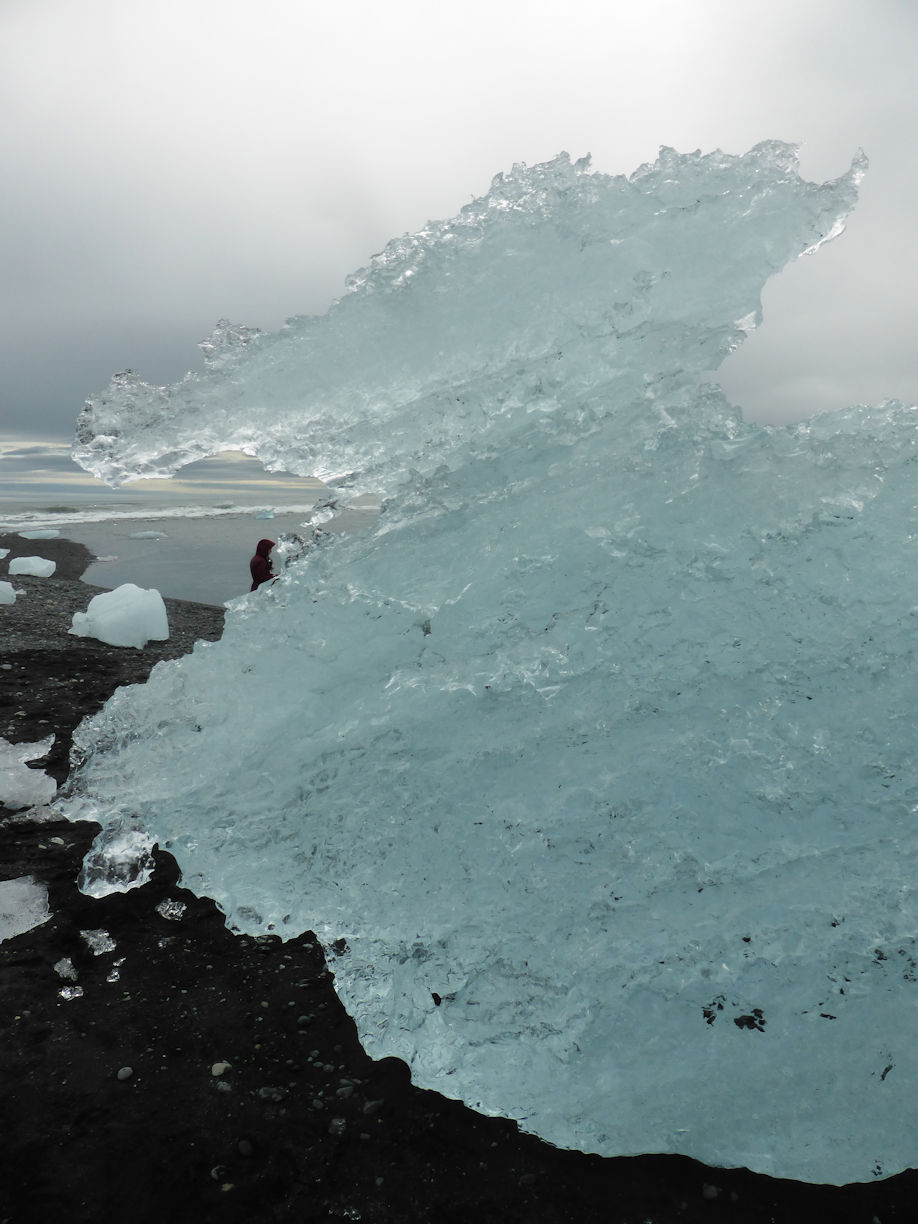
<box><xmin>0</xmin><ymin>0</ymin><xmax>918</xmax><ymax>439</ymax></box>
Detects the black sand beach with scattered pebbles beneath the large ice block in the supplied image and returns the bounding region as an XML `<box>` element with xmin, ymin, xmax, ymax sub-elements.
<box><xmin>0</xmin><ymin>535</ymin><xmax>918</xmax><ymax>1224</ymax></box>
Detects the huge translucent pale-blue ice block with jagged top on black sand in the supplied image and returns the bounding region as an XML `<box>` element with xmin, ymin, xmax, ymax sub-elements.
<box><xmin>67</xmin><ymin>143</ymin><xmax>918</xmax><ymax>1182</ymax></box>
